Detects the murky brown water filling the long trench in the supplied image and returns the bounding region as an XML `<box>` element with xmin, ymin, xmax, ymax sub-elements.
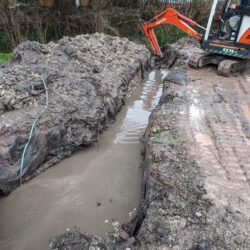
<box><xmin>0</xmin><ymin>71</ymin><xmax>166</xmax><ymax>250</ymax></box>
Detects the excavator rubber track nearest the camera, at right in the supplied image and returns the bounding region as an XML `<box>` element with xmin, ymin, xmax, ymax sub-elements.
<box><xmin>218</xmin><ymin>59</ymin><xmax>247</xmax><ymax>77</ymax></box>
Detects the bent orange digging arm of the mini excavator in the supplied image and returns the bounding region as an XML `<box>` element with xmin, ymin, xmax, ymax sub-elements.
<box><xmin>143</xmin><ymin>8</ymin><xmax>205</xmax><ymax>56</ymax></box>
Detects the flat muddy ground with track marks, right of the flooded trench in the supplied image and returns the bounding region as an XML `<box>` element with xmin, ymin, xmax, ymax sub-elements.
<box><xmin>50</xmin><ymin>39</ymin><xmax>250</xmax><ymax>250</ymax></box>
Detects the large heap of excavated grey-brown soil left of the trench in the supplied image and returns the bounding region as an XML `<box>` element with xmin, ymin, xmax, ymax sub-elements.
<box><xmin>0</xmin><ymin>33</ymin><xmax>150</xmax><ymax>194</ymax></box>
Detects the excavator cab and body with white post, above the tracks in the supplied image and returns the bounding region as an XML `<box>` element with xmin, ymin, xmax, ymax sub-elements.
<box><xmin>201</xmin><ymin>0</ymin><xmax>250</xmax><ymax>59</ymax></box>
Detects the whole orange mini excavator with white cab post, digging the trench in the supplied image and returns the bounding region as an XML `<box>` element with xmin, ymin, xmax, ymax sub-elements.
<box><xmin>143</xmin><ymin>0</ymin><xmax>250</xmax><ymax>76</ymax></box>
